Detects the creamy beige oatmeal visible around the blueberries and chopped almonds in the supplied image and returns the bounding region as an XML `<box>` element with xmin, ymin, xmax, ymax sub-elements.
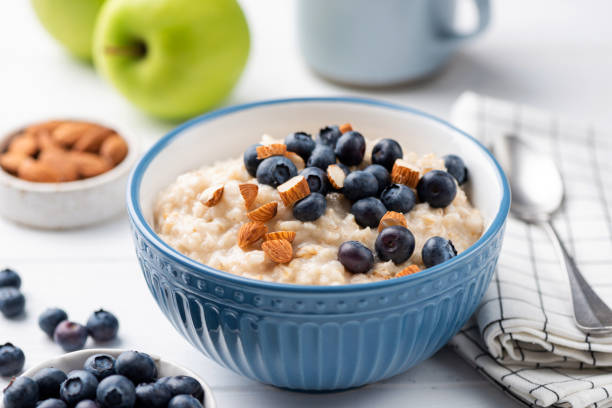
<box><xmin>155</xmin><ymin>138</ymin><xmax>483</xmax><ymax>285</ymax></box>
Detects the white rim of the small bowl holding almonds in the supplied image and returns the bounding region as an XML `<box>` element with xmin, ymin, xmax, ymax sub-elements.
<box><xmin>0</xmin><ymin>117</ymin><xmax>140</xmax><ymax>194</ymax></box>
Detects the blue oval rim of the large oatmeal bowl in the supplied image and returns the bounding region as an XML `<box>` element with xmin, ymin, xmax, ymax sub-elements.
<box><xmin>127</xmin><ymin>97</ymin><xmax>510</xmax><ymax>294</ymax></box>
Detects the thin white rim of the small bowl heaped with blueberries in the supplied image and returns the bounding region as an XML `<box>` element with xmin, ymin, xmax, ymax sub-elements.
<box><xmin>17</xmin><ymin>348</ymin><xmax>217</xmax><ymax>408</ymax></box>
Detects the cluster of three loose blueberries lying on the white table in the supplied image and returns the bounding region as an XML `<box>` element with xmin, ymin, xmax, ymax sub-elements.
<box><xmin>38</xmin><ymin>307</ymin><xmax>119</xmax><ymax>351</ymax></box>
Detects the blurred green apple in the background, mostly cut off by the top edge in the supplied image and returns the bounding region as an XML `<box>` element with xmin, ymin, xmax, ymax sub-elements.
<box><xmin>32</xmin><ymin>0</ymin><xmax>104</xmax><ymax>59</ymax></box>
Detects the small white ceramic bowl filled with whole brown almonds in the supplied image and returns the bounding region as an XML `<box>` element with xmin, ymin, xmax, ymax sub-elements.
<box><xmin>0</xmin><ymin>120</ymin><xmax>138</xmax><ymax>229</ymax></box>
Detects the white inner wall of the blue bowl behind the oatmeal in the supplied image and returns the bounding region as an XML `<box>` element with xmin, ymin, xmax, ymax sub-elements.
<box><xmin>140</xmin><ymin>101</ymin><xmax>503</xmax><ymax>239</ymax></box>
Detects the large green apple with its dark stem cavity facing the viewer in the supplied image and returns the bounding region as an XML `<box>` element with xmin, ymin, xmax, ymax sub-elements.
<box><xmin>94</xmin><ymin>0</ymin><xmax>249</xmax><ymax>120</ymax></box>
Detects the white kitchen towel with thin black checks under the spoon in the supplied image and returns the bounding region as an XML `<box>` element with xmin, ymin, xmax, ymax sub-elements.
<box><xmin>450</xmin><ymin>93</ymin><xmax>612</xmax><ymax>408</ymax></box>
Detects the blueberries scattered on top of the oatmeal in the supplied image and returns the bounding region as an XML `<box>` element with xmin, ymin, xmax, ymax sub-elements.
<box><xmin>244</xmin><ymin>126</ymin><xmax>467</xmax><ymax>273</ymax></box>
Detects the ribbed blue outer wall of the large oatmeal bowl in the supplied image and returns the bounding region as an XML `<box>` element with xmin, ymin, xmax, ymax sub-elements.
<box><xmin>133</xmin><ymin>218</ymin><xmax>504</xmax><ymax>390</ymax></box>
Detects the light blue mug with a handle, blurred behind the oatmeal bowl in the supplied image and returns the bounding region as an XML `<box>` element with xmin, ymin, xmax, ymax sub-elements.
<box><xmin>297</xmin><ymin>0</ymin><xmax>490</xmax><ymax>86</ymax></box>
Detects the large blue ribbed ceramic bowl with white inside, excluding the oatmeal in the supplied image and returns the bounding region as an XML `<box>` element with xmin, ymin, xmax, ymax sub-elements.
<box><xmin>128</xmin><ymin>98</ymin><xmax>510</xmax><ymax>390</ymax></box>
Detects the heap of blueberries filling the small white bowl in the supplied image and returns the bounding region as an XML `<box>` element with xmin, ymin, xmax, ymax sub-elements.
<box><xmin>4</xmin><ymin>351</ymin><xmax>204</xmax><ymax>408</ymax></box>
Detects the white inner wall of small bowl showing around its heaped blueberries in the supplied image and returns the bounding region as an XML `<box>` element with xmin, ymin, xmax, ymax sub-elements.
<box><xmin>11</xmin><ymin>349</ymin><xmax>217</xmax><ymax>408</ymax></box>
